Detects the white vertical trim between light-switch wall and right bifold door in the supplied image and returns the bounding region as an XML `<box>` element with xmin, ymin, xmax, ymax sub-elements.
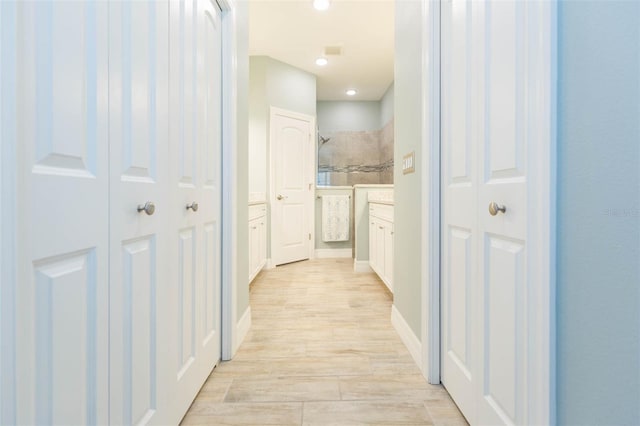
<box><xmin>420</xmin><ymin>0</ymin><xmax>442</xmax><ymax>384</ymax></box>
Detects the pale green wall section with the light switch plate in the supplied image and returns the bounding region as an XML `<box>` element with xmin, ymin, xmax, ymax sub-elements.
<box><xmin>393</xmin><ymin>1</ymin><xmax>426</xmax><ymax>339</ymax></box>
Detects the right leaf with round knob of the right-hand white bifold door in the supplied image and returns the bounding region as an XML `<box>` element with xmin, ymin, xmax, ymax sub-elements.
<box><xmin>474</xmin><ymin>2</ymin><xmax>528</xmax><ymax>424</ymax></box>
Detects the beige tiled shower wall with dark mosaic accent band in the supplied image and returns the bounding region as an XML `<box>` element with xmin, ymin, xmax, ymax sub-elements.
<box><xmin>318</xmin><ymin>119</ymin><xmax>393</xmax><ymax>186</ymax></box>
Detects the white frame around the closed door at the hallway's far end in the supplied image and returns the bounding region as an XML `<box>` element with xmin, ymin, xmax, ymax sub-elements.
<box><xmin>267</xmin><ymin>106</ymin><xmax>317</xmax><ymax>266</ymax></box>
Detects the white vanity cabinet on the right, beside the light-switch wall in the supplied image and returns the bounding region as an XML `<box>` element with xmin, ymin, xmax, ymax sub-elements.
<box><xmin>369</xmin><ymin>203</ymin><xmax>393</xmax><ymax>292</ymax></box>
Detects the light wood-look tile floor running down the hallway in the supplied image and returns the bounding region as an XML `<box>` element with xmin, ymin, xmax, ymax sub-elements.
<box><xmin>182</xmin><ymin>259</ymin><xmax>467</xmax><ymax>425</ymax></box>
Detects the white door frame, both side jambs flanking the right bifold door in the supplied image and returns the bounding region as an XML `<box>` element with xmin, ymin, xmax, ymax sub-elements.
<box><xmin>420</xmin><ymin>0</ymin><xmax>558</xmax><ymax>424</ymax></box>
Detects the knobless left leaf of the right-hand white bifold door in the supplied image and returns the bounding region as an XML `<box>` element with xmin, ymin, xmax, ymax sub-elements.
<box><xmin>441</xmin><ymin>0</ymin><xmax>479</xmax><ymax>423</ymax></box>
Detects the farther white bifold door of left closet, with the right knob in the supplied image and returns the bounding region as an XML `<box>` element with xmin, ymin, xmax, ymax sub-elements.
<box><xmin>168</xmin><ymin>0</ymin><xmax>222</xmax><ymax>422</ymax></box>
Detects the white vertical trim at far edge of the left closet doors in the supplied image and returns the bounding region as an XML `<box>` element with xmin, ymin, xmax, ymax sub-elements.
<box><xmin>218</xmin><ymin>0</ymin><xmax>238</xmax><ymax>360</ymax></box>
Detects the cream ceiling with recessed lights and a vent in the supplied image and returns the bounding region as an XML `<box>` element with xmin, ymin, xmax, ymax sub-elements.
<box><xmin>249</xmin><ymin>0</ymin><xmax>394</xmax><ymax>101</ymax></box>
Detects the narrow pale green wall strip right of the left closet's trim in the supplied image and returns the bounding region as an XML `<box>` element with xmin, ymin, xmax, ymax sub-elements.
<box><xmin>235</xmin><ymin>1</ymin><xmax>249</xmax><ymax>319</ymax></box>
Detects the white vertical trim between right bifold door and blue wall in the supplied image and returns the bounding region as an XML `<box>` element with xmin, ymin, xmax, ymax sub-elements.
<box><xmin>525</xmin><ymin>1</ymin><xmax>558</xmax><ymax>424</ymax></box>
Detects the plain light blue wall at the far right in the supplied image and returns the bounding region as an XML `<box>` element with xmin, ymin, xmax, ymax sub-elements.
<box><xmin>557</xmin><ymin>1</ymin><xmax>640</xmax><ymax>425</ymax></box>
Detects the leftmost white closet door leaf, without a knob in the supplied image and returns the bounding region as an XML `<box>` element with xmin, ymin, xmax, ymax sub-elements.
<box><xmin>12</xmin><ymin>1</ymin><xmax>109</xmax><ymax>424</ymax></box>
